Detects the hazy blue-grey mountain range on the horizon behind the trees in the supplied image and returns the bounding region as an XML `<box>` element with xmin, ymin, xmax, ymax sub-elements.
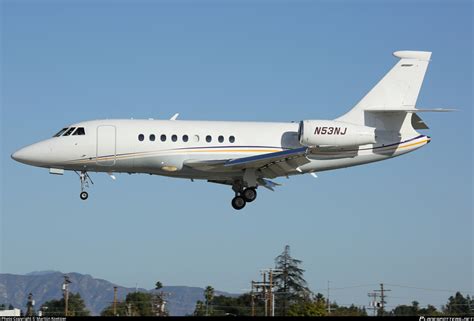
<box><xmin>0</xmin><ymin>271</ymin><xmax>235</xmax><ymax>316</ymax></box>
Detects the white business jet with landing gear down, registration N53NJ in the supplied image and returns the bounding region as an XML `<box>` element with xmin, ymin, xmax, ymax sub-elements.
<box><xmin>12</xmin><ymin>51</ymin><xmax>450</xmax><ymax>210</ymax></box>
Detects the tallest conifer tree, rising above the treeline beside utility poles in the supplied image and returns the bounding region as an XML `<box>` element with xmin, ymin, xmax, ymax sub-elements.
<box><xmin>274</xmin><ymin>245</ymin><xmax>311</xmax><ymax>316</ymax></box>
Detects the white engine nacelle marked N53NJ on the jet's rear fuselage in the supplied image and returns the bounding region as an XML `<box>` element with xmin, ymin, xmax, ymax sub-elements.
<box><xmin>298</xmin><ymin>120</ymin><xmax>375</xmax><ymax>147</ymax></box>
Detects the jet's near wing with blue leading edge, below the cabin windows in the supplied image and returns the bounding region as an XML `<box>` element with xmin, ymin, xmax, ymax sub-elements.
<box><xmin>185</xmin><ymin>147</ymin><xmax>310</xmax><ymax>178</ymax></box>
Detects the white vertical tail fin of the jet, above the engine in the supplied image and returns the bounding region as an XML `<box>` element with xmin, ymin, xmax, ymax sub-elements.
<box><xmin>336</xmin><ymin>51</ymin><xmax>431</xmax><ymax>131</ymax></box>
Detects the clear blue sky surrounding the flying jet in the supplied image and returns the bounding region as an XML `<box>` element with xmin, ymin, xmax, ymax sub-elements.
<box><xmin>0</xmin><ymin>0</ymin><xmax>474</xmax><ymax>306</ymax></box>
